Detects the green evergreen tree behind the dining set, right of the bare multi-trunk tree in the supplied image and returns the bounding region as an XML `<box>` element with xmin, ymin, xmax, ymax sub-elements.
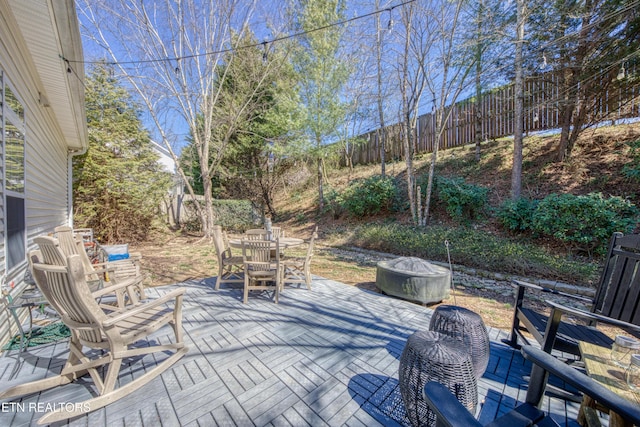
<box><xmin>219</xmin><ymin>35</ymin><xmax>299</xmax><ymax>217</ymax></box>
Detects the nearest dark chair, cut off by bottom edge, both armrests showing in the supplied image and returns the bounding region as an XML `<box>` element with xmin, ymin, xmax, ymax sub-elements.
<box><xmin>424</xmin><ymin>345</ymin><xmax>640</xmax><ymax>427</ymax></box>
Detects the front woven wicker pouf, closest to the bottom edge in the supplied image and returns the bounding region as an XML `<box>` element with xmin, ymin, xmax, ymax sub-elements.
<box><xmin>398</xmin><ymin>331</ymin><xmax>478</xmax><ymax>426</ymax></box>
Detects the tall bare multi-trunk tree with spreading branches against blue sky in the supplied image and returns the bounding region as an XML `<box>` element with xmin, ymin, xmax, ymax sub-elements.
<box><xmin>78</xmin><ymin>0</ymin><xmax>280</xmax><ymax>237</ymax></box>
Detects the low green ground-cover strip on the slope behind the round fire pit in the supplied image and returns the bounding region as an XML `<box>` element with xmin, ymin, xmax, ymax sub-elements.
<box><xmin>330</xmin><ymin>224</ymin><xmax>599</xmax><ymax>285</ymax></box>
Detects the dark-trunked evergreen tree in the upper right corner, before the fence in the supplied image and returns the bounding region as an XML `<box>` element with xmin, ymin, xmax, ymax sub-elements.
<box><xmin>525</xmin><ymin>0</ymin><xmax>640</xmax><ymax>161</ymax></box>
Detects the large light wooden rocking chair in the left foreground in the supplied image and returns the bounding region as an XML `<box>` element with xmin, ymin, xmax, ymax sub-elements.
<box><xmin>0</xmin><ymin>238</ymin><xmax>187</xmax><ymax>424</ymax></box>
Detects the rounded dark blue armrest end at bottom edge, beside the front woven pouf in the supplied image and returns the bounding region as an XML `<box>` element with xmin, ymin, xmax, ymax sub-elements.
<box><xmin>423</xmin><ymin>381</ymin><xmax>482</xmax><ymax>427</ymax></box>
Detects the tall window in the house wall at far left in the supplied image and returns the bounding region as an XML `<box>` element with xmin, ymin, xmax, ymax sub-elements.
<box><xmin>0</xmin><ymin>74</ymin><xmax>26</xmax><ymax>271</ymax></box>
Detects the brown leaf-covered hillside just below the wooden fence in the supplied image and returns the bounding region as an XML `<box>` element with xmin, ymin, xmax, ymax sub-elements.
<box><xmin>276</xmin><ymin>123</ymin><xmax>640</xmax><ymax>227</ymax></box>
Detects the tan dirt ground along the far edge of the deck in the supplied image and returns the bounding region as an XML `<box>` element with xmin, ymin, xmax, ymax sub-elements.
<box><xmin>131</xmin><ymin>233</ymin><xmax>528</xmax><ymax>329</ymax></box>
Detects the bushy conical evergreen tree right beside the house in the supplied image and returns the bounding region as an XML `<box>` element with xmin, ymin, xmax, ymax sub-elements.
<box><xmin>73</xmin><ymin>64</ymin><xmax>171</xmax><ymax>243</ymax></box>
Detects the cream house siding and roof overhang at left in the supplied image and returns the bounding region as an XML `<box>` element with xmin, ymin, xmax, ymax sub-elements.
<box><xmin>0</xmin><ymin>0</ymin><xmax>86</xmax><ymax>346</ymax></box>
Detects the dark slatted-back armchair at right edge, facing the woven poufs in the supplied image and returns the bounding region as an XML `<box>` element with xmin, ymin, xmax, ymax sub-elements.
<box><xmin>504</xmin><ymin>233</ymin><xmax>640</xmax><ymax>358</ymax></box>
